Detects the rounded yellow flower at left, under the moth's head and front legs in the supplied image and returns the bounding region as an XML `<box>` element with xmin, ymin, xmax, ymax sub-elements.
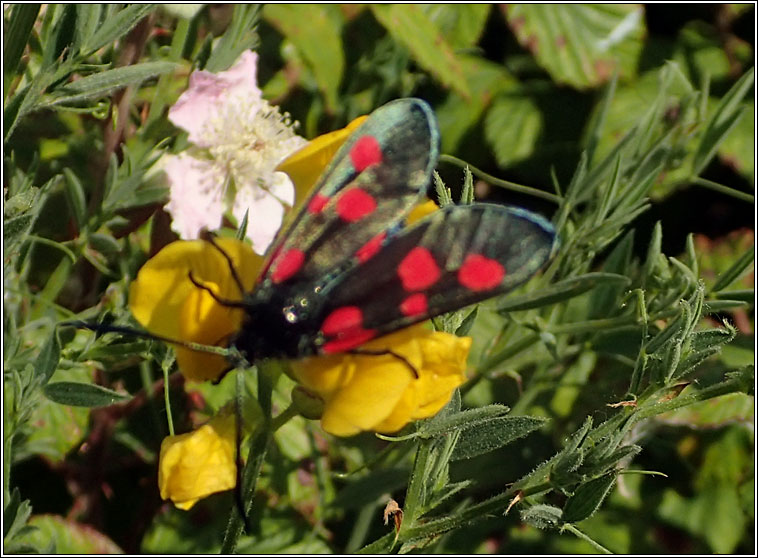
<box><xmin>129</xmin><ymin>238</ymin><xmax>263</xmax><ymax>381</ymax></box>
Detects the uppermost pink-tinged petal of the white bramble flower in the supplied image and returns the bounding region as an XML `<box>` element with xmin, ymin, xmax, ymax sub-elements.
<box><xmin>168</xmin><ymin>51</ymin><xmax>262</xmax><ymax>147</ymax></box>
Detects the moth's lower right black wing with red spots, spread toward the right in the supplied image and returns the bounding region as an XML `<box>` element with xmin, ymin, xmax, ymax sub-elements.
<box><xmin>318</xmin><ymin>203</ymin><xmax>555</xmax><ymax>353</ymax></box>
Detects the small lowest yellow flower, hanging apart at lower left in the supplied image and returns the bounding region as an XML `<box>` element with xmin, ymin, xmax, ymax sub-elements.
<box><xmin>158</xmin><ymin>414</ymin><xmax>237</xmax><ymax>510</ymax></box>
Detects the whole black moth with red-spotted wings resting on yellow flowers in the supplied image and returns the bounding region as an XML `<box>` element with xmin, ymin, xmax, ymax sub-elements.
<box><xmin>220</xmin><ymin>98</ymin><xmax>556</xmax><ymax>361</ymax></box>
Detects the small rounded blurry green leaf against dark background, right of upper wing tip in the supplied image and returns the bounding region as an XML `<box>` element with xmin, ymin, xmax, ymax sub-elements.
<box><xmin>484</xmin><ymin>91</ymin><xmax>543</xmax><ymax>167</ymax></box>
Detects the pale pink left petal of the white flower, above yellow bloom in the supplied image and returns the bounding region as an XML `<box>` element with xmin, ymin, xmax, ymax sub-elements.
<box><xmin>163</xmin><ymin>153</ymin><xmax>224</xmax><ymax>239</ymax></box>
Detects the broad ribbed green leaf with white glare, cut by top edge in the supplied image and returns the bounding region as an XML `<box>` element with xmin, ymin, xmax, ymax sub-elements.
<box><xmin>503</xmin><ymin>4</ymin><xmax>645</xmax><ymax>89</ymax></box>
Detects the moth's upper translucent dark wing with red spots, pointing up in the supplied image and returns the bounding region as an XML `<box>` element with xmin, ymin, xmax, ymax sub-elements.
<box><xmin>259</xmin><ymin>99</ymin><xmax>439</xmax><ymax>288</ymax></box>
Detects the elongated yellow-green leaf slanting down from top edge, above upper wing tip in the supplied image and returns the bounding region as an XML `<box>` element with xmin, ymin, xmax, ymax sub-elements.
<box><xmin>371</xmin><ymin>4</ymin><xmax>470</xmax><ymax>99</ymax></box>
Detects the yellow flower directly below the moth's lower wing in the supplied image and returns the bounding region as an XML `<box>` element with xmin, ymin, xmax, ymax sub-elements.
<box><xmin>292</xmin><ymin>325</ymin><xmax>471</xmax><ymax>436</ymax></box>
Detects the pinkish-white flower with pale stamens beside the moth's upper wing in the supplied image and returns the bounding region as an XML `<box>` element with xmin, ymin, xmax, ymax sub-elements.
<box><xmin>163</xmin><ymin>51</ymin><xmax>306</xmax><ymax>254</ymax></box>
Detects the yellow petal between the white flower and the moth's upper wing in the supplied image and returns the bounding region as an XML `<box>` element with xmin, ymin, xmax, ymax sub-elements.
<box><xmin>276</xmin><ymin>116</ymin><xmax>367</xmax><ymax>206</ymax></box>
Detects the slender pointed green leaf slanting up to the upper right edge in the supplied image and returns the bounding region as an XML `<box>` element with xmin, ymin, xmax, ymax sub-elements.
<box><xmin>692</xmin><ymin>68</ymin><xmax>755</xmax><ymax>176</ymax></box>
